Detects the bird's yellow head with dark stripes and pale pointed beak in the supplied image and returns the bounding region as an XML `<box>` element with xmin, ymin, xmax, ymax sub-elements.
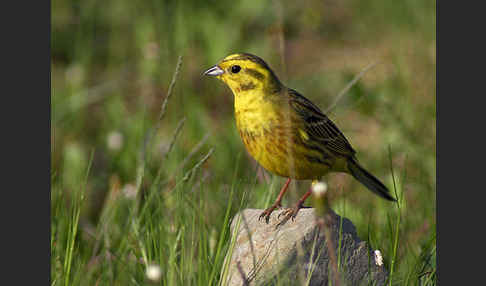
<box><xmin>204</xmin><ymin>53</ymin><xmax>282</xmax><ymax>96</ymax></box>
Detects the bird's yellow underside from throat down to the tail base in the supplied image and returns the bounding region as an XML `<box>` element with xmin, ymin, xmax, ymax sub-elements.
<box><xmin>235</xmin><ymin>91</ymin><xmax>329</xmax><ymax>179</ymax></box>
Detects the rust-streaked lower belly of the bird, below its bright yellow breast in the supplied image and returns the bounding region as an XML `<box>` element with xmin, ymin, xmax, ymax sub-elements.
<box><xmin>240</xmin><ymin>125</ymin><xmax>331</xmax><ymax>180</ymax></box>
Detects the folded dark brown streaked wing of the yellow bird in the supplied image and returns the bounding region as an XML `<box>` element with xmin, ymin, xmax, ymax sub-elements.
<box><xmin>288</xmin><ymin>89</ymin><xmax>356</xmax><ymax>157</ymax></box>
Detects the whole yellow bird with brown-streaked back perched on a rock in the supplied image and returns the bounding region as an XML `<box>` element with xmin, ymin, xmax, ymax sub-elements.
<box><xmin>204</xmin><ymin>53</ymin><xmax>396</xmax><ymax>223</ymax></box>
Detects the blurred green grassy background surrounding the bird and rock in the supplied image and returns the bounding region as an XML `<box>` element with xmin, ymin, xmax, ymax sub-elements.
<box><xmin>51</xmin><ymin>0</ymin><xmax>436</xmax><ymax>285</ymax></box>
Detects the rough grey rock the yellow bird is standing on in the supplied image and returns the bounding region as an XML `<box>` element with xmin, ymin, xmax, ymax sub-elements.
<box><xmin>221</xmin><ymin>209</ymin><xmax>388</xmax><ymax>285</ymax></box>
